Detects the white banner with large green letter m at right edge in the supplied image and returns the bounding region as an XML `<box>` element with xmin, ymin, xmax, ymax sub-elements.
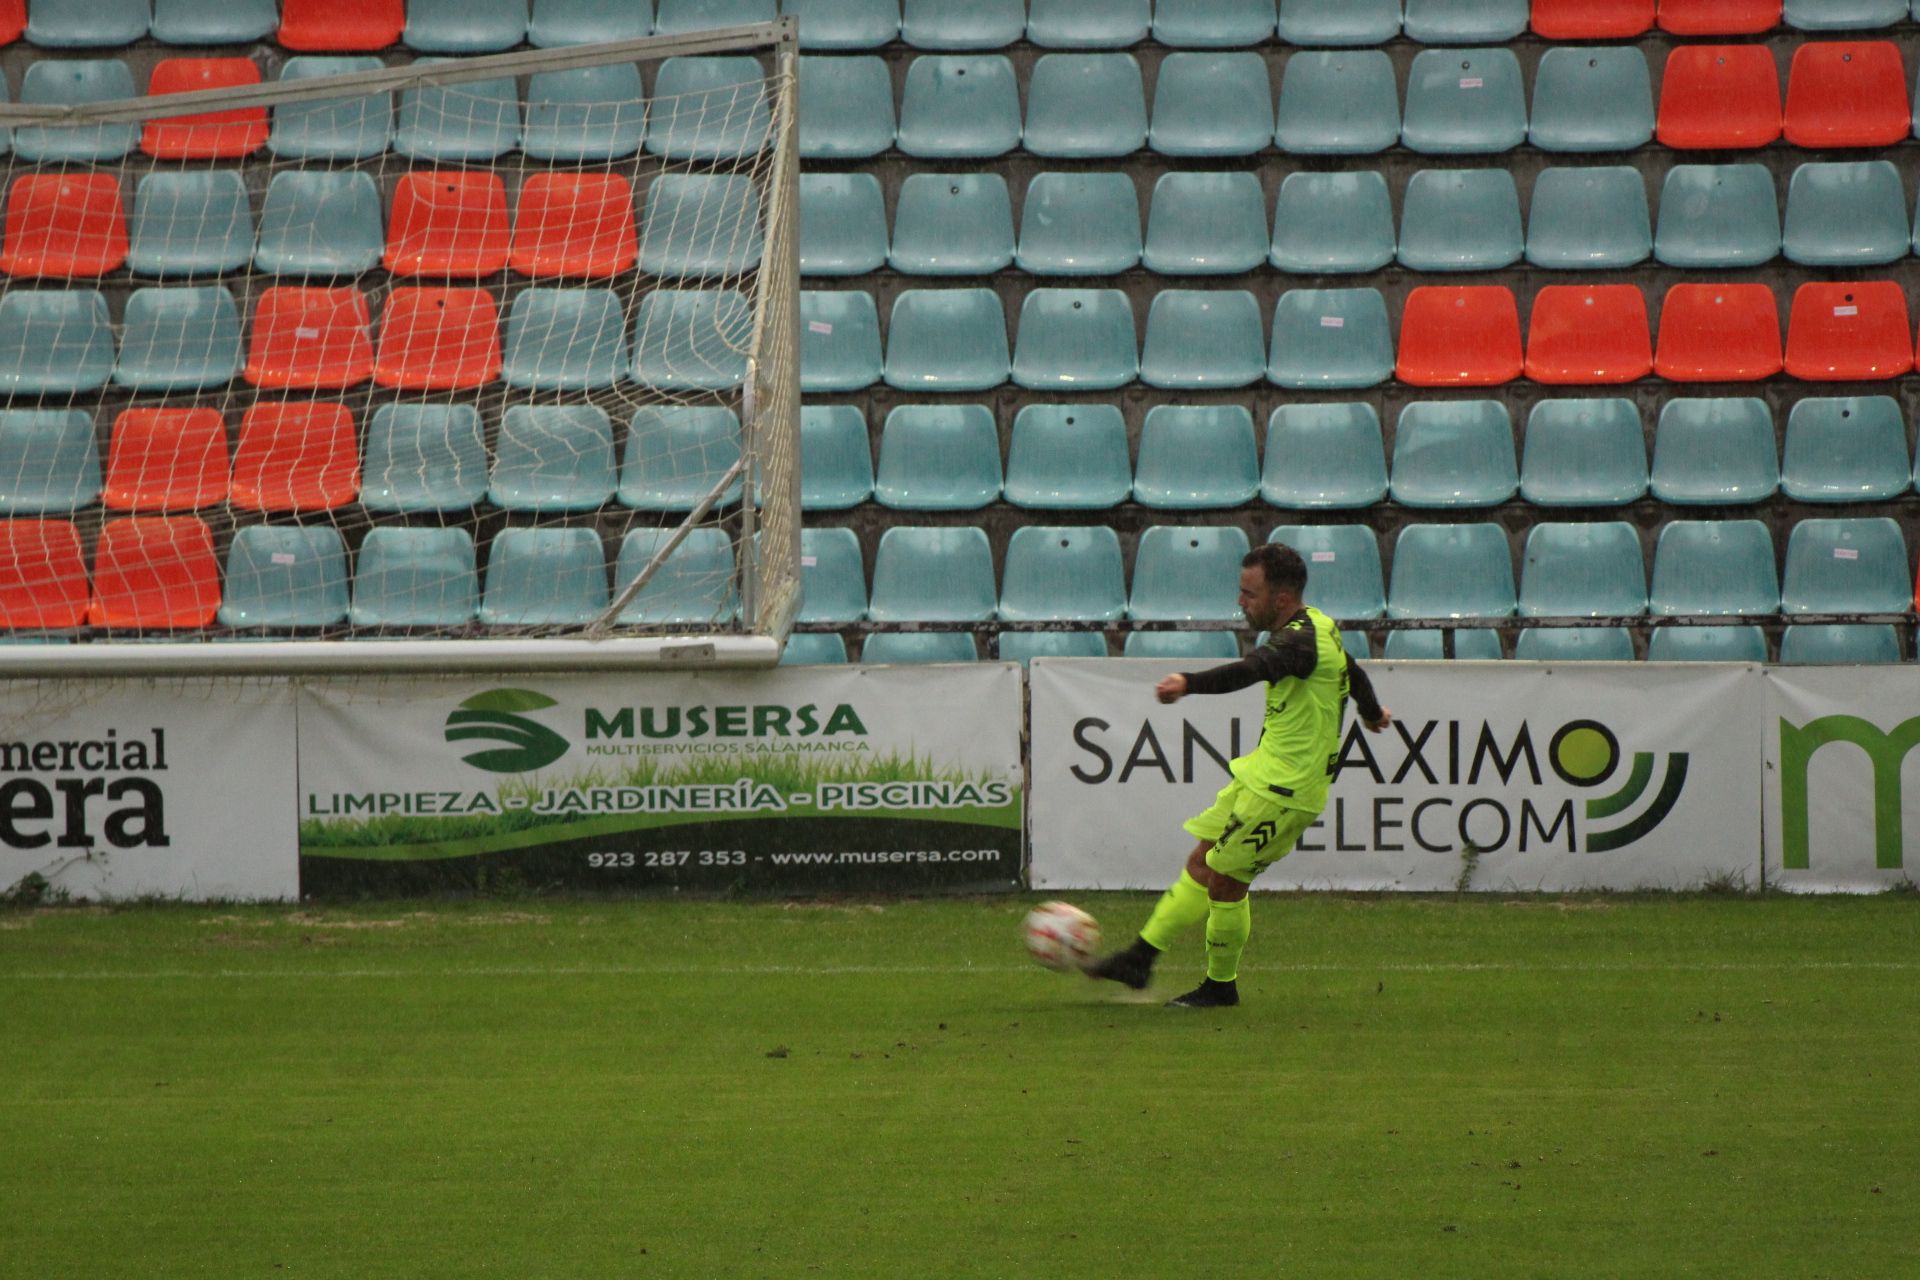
<box><xmin>1764</xmin><ymin>666</ymin><xmax>1920</xmax><ymax>892</ymax></box>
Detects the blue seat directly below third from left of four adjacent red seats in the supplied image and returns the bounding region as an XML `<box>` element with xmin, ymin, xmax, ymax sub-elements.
<box><xmin>1651</xmin><ymin>397</ymin><xmax>1780</xmax><ymax>507</ymax></box>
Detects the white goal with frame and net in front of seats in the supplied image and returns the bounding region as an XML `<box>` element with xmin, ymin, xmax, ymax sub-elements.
<box><xmin>0</xmin><ymin>21</ymin><xmax>799</xmax><ymax>674</ymax></box>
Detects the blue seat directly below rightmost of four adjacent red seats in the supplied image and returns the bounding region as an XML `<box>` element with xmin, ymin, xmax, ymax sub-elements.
<box><xmin>1780</xmin><ymin>395</ymin><xmax>1912</xmax><ymax>503</ymax></box>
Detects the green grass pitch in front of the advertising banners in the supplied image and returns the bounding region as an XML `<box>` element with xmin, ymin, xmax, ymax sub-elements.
<box><xmin>0</xmin><ymin>894</ymin><xmax>1920</xmax><ymax>1280</ymax></box>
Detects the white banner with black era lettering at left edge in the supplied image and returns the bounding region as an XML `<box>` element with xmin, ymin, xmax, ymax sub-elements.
<box><xmin>0</xmin><ymin>679</ymin><xmax>300</xmax><ymax>900</ymax></box>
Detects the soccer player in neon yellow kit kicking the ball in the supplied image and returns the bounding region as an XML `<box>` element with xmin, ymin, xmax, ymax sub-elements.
<box><xmin>1089</xmin><ymin>543</ymin><xmax>1394</xmax><ymax>1009</ymax></box>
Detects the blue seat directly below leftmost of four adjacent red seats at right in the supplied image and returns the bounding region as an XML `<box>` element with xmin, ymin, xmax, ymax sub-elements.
<box><xmin>1390</xmin><ymin>399</ymin><xmax>1521</xmax><ymax>507</ymax></box>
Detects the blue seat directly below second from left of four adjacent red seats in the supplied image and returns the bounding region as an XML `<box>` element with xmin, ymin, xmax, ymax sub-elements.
<box><xmin>1521</xmin><ymin>397</ymin><xmax>1647</xmax><ymax>507</ymax></box>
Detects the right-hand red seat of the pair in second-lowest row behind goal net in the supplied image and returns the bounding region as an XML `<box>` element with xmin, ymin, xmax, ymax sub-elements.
<box><xmin>232</xmin><ymin>401</ymin><xmax>359</xmax><ymax>510</ymax></box>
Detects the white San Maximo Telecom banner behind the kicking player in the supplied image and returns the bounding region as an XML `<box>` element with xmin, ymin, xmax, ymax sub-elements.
<box><xmin>1031</xmin><ymin>658</ymin><xmax>1764</xmax><ymax>890</ymax></box>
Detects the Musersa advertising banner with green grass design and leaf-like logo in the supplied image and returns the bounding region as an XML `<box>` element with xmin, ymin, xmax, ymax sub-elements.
<box><xmin>300</xmin><ymin>664</ymin><xmax>1023</xmax><ymax>892</ymax></box>
